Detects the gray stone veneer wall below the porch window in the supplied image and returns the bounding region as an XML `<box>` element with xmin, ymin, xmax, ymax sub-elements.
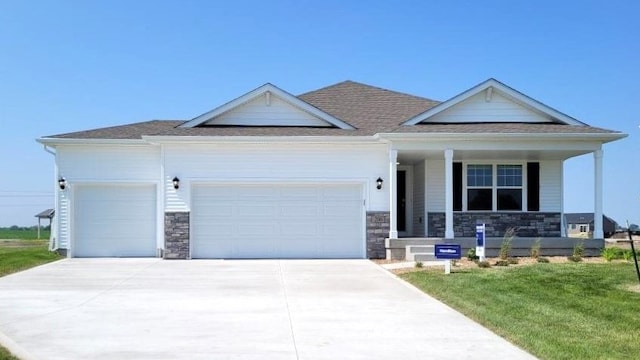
<box><xmin>427</xmin><ymin>212</ymin><xmax>561</xmax><ymax>237</ymax></box>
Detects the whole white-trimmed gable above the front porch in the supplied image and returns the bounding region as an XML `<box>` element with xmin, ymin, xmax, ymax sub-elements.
<box><xmin>403</xmin><ymin>79</ymin><xmax>585</xmax><ymax>126</ymax></box>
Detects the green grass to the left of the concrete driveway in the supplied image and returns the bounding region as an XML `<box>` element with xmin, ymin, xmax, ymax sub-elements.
<box><xmin>0</xmin><ymin>235</ymin><xmax>62</xmax><ymax>360</ymax></box>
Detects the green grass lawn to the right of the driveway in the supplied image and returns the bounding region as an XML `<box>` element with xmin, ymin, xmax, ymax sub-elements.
<box><xmin>401</xmin><ymin>262</ymin><xmax>640</xmax><ymax>359</ymax></box>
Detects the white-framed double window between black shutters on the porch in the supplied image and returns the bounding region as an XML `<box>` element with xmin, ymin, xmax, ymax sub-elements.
<box><xmin>467</xmin><ymin>164</ymin><xmax>523</xmax><ymax>211</ymax></box>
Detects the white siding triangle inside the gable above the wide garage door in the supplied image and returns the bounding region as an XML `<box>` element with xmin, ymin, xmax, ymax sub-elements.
<box><xmin>201</xmin><ymin>92</ymin><xmax>334</xmax><ymax>127</ymax></box>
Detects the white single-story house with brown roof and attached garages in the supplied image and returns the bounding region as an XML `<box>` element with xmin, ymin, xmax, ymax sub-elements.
<box><xmin>38</xmin><ymin>79</ymin><xmax>626</xmax><ymax>259</ymax></box>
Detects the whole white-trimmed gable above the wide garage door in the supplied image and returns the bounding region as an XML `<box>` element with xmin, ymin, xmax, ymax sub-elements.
<box><xmin>180</xmin><ymin>83</ymin><xmax>354</xmax><ymax>129</ymax></box>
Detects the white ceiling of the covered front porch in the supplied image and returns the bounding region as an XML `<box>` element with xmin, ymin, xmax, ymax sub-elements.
<box><xmin>398</xmin><ymin>149</ymin><xmax>593</xmax><ymax>165</ymax></box>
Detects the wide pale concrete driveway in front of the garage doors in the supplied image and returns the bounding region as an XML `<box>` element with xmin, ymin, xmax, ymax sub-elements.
<box><xmin>0</xmin><ymin>259</ymin><xmax>532</xmax><ymax>360</ymax></box>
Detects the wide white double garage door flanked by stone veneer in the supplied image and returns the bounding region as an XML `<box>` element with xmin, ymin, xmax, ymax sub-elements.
<box><xmin>191</xmin><ymin>184</ymin><xmax>364</xmax><ymax>258</ymax></box>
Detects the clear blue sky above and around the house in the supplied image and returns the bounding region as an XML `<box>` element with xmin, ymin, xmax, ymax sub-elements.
<box><xmin>0</xmin><ymin>0</ymin><xmax>640</xmax><ymax>226</ymax></box>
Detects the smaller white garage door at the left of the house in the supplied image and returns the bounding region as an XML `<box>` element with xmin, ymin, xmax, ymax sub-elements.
<box><xmin>73</xmin><ymin>185</ymin><xmax>156</xmax><ymax>257</ymax></box>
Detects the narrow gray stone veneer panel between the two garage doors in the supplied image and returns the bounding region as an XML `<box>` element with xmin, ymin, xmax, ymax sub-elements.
<box><xmin>164</xmin><ymin>212</ymin><xmax>189</xmax><ymax>259</ymax></box>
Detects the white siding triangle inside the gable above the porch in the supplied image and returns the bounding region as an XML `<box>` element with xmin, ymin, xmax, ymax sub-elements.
<box><xmin>422</xmin><ymin>90</ymin><xmax>555</xmax><ymax>123</ymax></box>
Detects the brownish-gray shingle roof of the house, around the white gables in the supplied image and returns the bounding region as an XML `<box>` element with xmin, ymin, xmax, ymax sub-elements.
<box><xmin>42</xmin><ymin>81</ymin><xmax>617</xmax><ymax>139</ymax></box>
